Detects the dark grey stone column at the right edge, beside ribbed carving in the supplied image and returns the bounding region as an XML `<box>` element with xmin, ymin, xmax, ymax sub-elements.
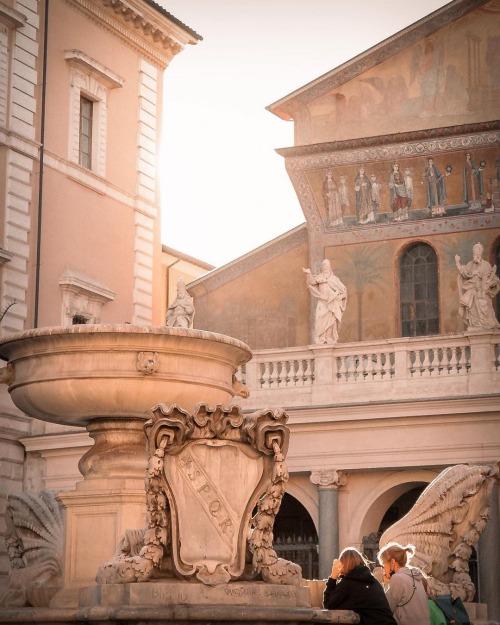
<box><xmin>478</xmin><ymin>464</ymin><xmax>500</xmax><ymax>621</ymax></box>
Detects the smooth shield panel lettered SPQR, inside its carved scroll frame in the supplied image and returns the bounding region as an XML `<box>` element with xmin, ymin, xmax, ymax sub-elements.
<box><xmin>164</xmin><ymin>439</ymin><xmax>272</xmax><ymax>585</ymax></box>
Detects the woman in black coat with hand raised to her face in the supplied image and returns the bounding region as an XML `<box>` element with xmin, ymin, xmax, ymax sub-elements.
<box><xmin>323</xmin><ymin>547</ymin><xmax>397</xmax><ymax>625</ymax></box>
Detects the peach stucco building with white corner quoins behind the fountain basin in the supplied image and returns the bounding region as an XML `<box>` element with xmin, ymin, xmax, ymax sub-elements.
<box><xmin>0</xmin><ymin>0</ymin><xmax>199</xmax><ymax>591</ymax></box>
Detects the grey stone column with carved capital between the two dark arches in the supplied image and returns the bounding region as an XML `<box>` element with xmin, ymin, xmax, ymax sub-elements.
<box><xmin>311</xmin><ymin>469</ymin><xmax>347</xmax><ymax>579</ymax></box>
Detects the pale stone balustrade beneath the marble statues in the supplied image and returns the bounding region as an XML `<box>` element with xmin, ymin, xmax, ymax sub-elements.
<box><xmin>238</xmin><ymin>331</ymin><xmax>500</xmax><ymax>408</ymax></box>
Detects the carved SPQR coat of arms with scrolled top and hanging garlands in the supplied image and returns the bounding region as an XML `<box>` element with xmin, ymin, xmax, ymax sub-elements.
<box><xmin>97</xmin><ymin>404</ymin><xmax>301</xmax><ymax>585</ymax></box>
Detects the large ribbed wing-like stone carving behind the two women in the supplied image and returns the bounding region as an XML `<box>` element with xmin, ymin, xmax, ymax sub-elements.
<box><xmin>380</xmin><ymin>465</ymin><xmax>499</xmax><ymax>601</ymax></box>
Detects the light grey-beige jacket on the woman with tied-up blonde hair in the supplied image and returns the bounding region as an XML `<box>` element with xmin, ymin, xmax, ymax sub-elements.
<box><xmin>386</xmin><ymin>566</ymin><xmax>431</xmax><ymax>625</ymax></box>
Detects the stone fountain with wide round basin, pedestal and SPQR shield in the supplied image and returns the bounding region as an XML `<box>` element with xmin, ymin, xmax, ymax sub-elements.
<box><xmin>0</xmin><ymin>325</ymin><xmax>358</xmax><ymax>624</ymax></box>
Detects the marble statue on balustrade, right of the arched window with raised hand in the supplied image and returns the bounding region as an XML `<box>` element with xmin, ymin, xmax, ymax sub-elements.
<box><xmin>455</xmin><ymin>243</ymin><xmax>500</xmax><ymax>330</ymax></box>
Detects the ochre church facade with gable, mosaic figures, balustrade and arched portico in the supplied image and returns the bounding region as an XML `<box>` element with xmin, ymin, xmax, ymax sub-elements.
<box><xmin>188</xmin><ymin>0</ymin><xmax>500</xmax><ymax>620</ymax></box>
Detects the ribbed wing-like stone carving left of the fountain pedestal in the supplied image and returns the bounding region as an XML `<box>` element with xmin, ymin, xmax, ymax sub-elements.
<box><xmin>0</xmin><ymin>489</ymin><xmax>63</xmax><ymax>606</ymax></box>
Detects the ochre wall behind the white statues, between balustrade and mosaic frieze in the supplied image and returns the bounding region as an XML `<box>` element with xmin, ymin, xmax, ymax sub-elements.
<box><xmin>191</xmin><ymin>228</ymin><xmax>500</xmax><ymax>349</ymax></box>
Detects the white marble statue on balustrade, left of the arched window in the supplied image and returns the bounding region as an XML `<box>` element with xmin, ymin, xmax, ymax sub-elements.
<box><xmin>303</xmin><ymin>259</ymin><xmax>347</xmax><ymax>345</ymax></box>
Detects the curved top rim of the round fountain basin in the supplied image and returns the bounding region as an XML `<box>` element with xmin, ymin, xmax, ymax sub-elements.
<box><xmin>0</xmin><ymin>323</ymin><xmax>252</xmax><ymax>362</ymax></box>
